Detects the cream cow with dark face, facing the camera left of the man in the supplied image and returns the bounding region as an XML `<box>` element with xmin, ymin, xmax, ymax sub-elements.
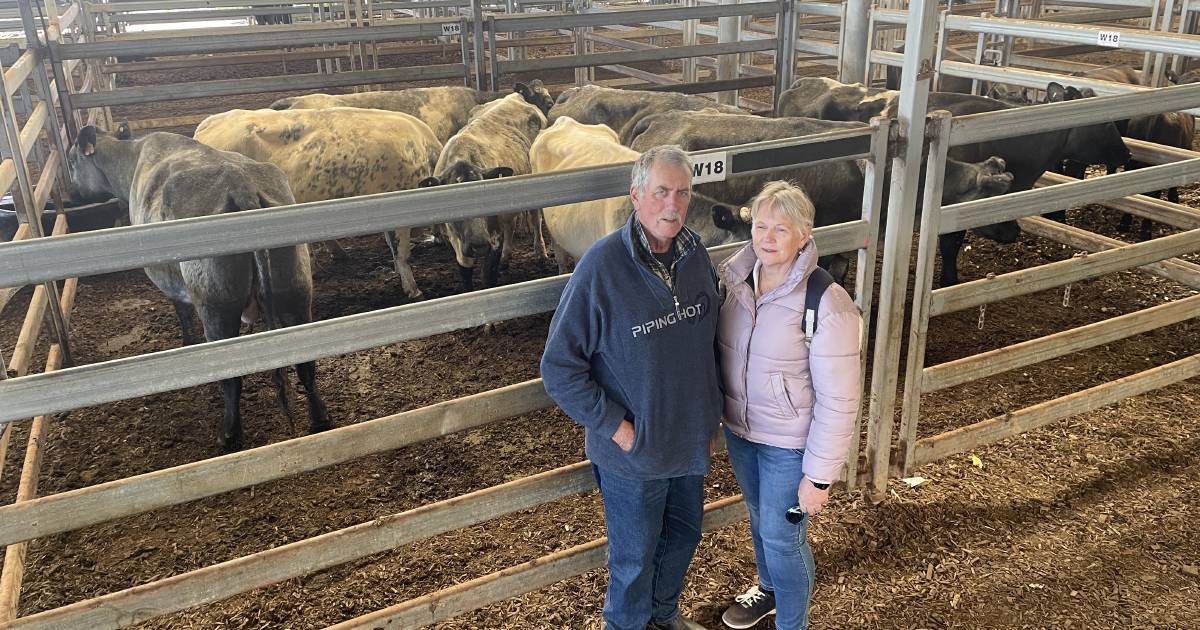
<box><xmin>420</xmin><ymin>94</ymin><xmax>546</xmax><ymax>290</ymax></box>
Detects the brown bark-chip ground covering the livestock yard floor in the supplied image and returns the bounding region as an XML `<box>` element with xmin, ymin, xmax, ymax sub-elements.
<box><xmin>0</xmin><ymin>40</ymin><xmax>1200</xmax><ymax>629</ymax></box>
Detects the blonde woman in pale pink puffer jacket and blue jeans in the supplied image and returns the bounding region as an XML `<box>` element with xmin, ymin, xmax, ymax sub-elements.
<box><xmin>718</xmin><ymin>181</ymin><xmax>862</xmax><ymax>630</ymax></box>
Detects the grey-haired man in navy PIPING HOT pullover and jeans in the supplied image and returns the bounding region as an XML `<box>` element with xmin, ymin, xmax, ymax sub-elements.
<box><xmin>541</xmin><ymin>146</ymin><xmax>722</xmax><ymax>630</ymax></box>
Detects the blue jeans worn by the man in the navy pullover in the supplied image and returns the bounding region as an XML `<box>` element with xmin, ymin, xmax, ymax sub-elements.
<box><xmin>592</xmin><ymin>466</ymin><xmax>704</xmax><ymax>630</ymax></box>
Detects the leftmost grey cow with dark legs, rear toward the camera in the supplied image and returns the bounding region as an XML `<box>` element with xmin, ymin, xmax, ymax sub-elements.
<box><xmin>68</xmin><ymin>126</ymin><xmax>332</xmax><ymax>450</ymax></box>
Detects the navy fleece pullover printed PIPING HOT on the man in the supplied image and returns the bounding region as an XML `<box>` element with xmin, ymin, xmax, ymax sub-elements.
<box><xmin>541</xmin><ymin>215</ymin><xmax>722</xmax><ymax>480</ymax></box>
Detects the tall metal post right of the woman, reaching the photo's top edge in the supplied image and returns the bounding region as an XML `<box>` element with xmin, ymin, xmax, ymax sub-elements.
<box><xmin>866</xmin><ymin>0</ymin><xmax>937</xmax><ymax>500</ymax></box>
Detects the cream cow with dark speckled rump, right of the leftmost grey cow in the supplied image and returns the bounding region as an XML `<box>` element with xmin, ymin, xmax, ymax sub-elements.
<box><xmin>194</xmin><ymin>107</ymin><xmax>442</xmax><ymax>300</ymax></box>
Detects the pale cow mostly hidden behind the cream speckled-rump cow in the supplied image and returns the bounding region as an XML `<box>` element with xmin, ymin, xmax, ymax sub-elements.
<box><xmin>270</xmin><ymin>79</ymin><xmax>554</xmax><ymax>144</ymax></box>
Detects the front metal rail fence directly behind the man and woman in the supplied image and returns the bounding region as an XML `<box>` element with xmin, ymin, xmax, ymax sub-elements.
<box><xmin>0</xmin><ymin>116</ymin><xmax>888</xmax><ymax>628</ymax></box>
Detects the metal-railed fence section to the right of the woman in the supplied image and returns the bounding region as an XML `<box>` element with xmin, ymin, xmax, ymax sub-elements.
<box><xmin>868</xmin><ymin>4</ymin><xmax>1200</xmax><ymax>496</ymax></box>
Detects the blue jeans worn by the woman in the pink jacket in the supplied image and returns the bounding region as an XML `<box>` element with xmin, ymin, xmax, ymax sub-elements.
<box><xmin>725</xmin><ymin>428</ymin><xmax>816</xmax><ymax>630</ymax></box>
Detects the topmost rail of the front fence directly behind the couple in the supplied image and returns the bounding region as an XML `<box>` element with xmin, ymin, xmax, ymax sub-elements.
<box><xmin>0</xmin><ymin>127</ymin><xmax>871</xmax><ymax>287</ymax></box>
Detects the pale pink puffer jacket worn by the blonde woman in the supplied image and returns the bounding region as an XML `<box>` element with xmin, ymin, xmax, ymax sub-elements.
<box><xmin>718</xmin><ymin>241</ymin><xmax>862</xmax><ymax>481</ymax></box>
